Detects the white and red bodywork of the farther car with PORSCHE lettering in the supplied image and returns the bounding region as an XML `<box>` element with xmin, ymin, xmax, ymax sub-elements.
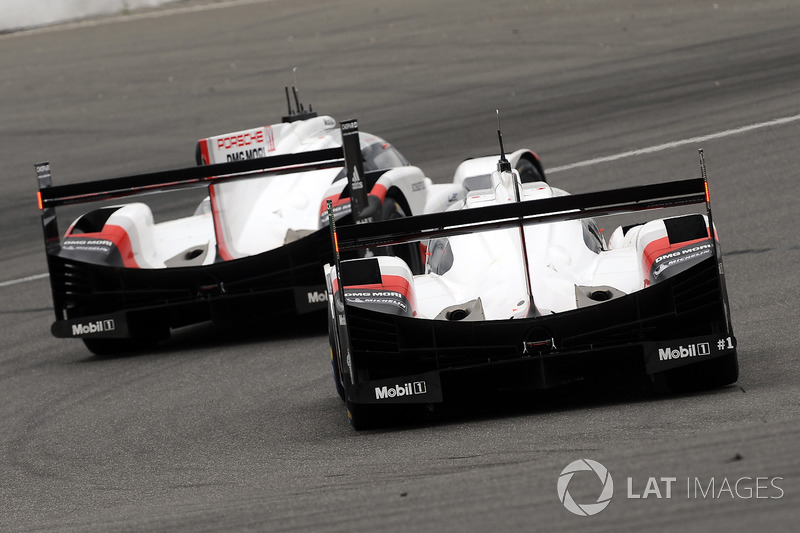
<box><xmin>65</xmin><ymin>116</ymin><xmax>463</xmax><ymax>268</ymax></box>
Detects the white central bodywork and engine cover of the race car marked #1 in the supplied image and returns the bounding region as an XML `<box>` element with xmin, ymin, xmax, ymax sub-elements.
<box><xmin>414</xmin><ymin>171</ymin><xmax>643</xmax><ymax>319</ymax></box>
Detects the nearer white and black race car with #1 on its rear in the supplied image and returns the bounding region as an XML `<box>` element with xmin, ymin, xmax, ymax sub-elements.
<box><xmin>325</xmin><ymin>142</ymin><xmax>738</xmax><ymax>429</ymax></box>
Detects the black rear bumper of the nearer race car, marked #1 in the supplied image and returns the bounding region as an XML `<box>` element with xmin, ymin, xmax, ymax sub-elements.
<box><xmin>344</xmin><ymin>258</ymin><xmax>736</xmax><ymax>403</ymax></box>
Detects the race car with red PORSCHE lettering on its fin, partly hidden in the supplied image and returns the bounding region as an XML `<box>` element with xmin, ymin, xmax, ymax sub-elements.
<box><xmin>36</xmin><ymin>95</ymin><xmax>506</xmax><ymax>354</ymax></box>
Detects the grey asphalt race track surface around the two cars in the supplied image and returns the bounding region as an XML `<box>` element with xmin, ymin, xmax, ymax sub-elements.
<box><xmin>0</xmin><ymin>0</ymin><xmax>800</xmax><ymax>532</ymax></box>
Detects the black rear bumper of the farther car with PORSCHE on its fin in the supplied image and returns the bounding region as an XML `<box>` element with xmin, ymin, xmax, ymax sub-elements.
<box><xmin>47</xmin><ymin>229</ymin><xmax>331</xmax><ymax>338</ymax></box>
